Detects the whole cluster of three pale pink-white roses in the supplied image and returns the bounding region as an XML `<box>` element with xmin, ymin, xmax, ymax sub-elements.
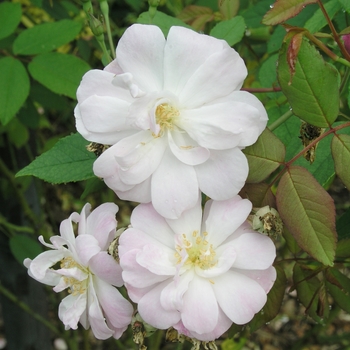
<box><xmin>24</xmin><ymin>24</ymin><xmax>276</xmax><ymax>342</ymax></box>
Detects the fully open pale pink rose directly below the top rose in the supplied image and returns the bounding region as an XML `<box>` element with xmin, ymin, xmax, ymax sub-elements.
<box><xmin>118</xmin><ymin>196</ymin><xmax>276</xmax><ymax>341</ymax></box>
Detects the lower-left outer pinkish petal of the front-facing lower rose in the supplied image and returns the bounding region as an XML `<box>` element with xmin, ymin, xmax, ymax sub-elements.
<box><xmin>137</xmin><ymin>280</ymin><xmax>180</xmax><ymax>329</ymax></box>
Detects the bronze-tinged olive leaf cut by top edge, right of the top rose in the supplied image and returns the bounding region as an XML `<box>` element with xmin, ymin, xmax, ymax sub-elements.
<box><xmin>262</xmin><ymin>0</ymin><xmax>317</xmax><ymax>26</ymax></box>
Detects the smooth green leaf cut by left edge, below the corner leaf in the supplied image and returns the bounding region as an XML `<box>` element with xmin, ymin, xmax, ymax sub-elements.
<box><xmin>0</xmin><ymin>57</ymin><xmax>30</xmax><ymax>125</ymax></box>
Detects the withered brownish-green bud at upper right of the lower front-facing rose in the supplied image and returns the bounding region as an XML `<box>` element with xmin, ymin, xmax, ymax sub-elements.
<box><xmin>252</xmin><ymin>205</ymin><xmax>283</xmax><ymax>238</ymax></box>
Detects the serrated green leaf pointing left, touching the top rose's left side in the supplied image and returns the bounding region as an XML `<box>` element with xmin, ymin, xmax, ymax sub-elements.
<box><xmin>16</xmin><ymin>133</ymin><xmax>96</xmax><ymax>184</ymax></box>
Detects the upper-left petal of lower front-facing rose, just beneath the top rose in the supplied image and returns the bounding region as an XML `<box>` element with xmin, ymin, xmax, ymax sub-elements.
<box><xmin>128</xmin><ymin>203</ymin><xmax>174</xmax><ymax>249</ymax></box>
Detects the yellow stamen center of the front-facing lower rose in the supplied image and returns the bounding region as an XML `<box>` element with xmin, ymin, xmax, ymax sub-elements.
<box><xmin>175</xmin><ymin>231</ymin><xmax>217</xmax><ymax>270</ymax></box>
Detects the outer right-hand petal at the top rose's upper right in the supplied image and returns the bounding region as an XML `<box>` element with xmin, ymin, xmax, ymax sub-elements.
<box><xmin>179</xmin><ymin>48</ymin><xmax>247</xmax><ymax>108</ymax></box>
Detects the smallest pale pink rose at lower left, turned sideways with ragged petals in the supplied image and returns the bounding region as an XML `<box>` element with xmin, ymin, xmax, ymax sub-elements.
<box><xmin>24</xmin><ymin>203</ymin><xmax>133</xmax><ymax>339</ymax></box>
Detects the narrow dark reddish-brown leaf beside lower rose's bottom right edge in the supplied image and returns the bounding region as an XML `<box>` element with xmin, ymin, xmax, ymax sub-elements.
<box><xmin>249</xmin><ymin>266</ymin><xmax>287</xmax><ymax>332</ymax></box>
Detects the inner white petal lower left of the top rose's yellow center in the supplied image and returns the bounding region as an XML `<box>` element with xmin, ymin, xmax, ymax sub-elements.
<box><xmin>114</xmin><ymin>131</ymin><xmax>166</xmax><ymax>185</ymax></box>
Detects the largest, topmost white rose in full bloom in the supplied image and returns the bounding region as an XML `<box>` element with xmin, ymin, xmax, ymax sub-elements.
<box><xmin>75</xmin><ymin>24</ymin><xmax>267</xmax><ymax>219</ymax></box>
